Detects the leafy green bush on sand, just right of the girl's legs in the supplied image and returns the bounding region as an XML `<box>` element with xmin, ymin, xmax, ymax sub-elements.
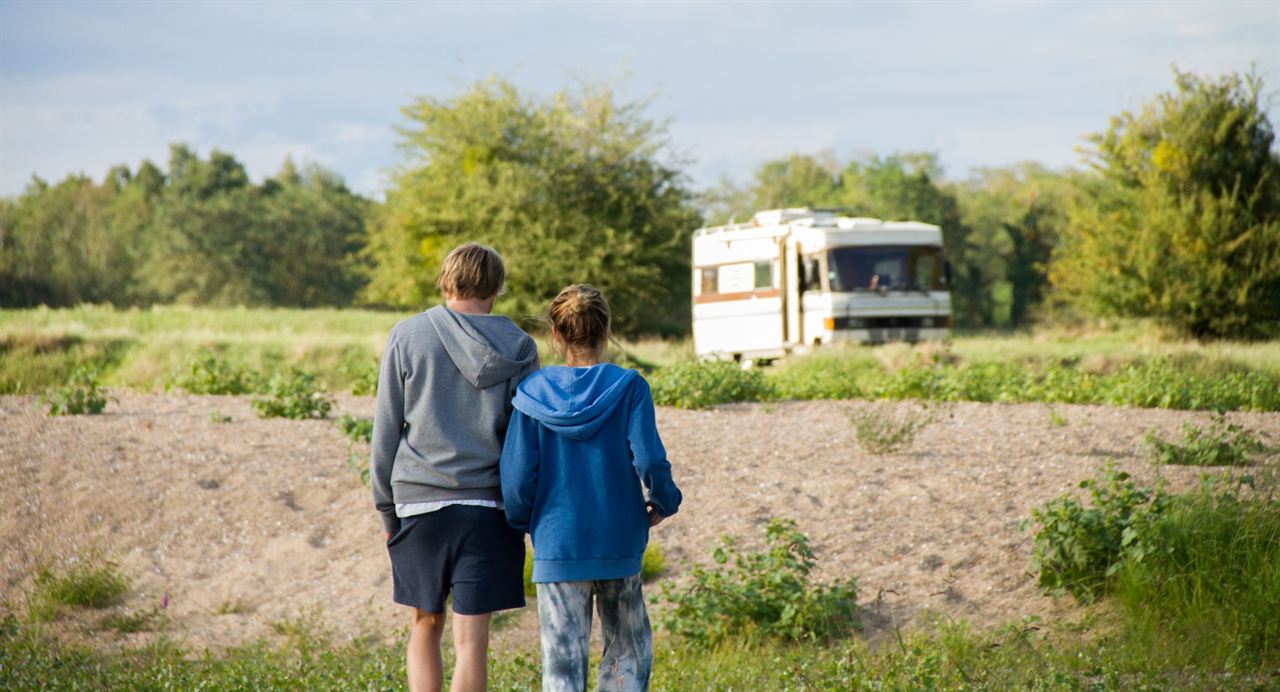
<box><xmin>662</xmin><ymin>519</ymin><xmax>860</xmax><ymax>646</ymax></box>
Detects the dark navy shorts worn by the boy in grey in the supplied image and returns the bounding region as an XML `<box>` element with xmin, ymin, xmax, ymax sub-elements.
<box><xmin>387</xmin><ymin>505</ymin><xmax>525</xmax><ymax>615</ymax></box>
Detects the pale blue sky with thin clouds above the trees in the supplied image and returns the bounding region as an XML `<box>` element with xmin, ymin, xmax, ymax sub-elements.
<box><xmin>0</xmin><ymin>0</ymin><xmax>1280</xmax><ymax>197</ymax></box>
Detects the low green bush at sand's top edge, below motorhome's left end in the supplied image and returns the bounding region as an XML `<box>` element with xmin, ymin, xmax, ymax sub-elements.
<box><xmin>650</xmin><ymin>361</ymin><xmax>773</xmax><ymax>408</ymax></box>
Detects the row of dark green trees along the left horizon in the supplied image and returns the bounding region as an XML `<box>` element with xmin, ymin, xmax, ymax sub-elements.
<box><xmin>0</xmin><ymin>145</ymin><xmax>369</xmax><ymax>307</ymax></box>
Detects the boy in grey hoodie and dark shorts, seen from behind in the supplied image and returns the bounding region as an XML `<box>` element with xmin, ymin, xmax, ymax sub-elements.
<box><xmin>370</xmin><ymin>243</ymin><xmax>539</xmax><ymax>691</ymax></box>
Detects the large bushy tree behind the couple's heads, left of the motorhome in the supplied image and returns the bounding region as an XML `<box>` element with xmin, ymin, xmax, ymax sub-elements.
<box><xmin>364</xmin><ymin>78</ymin><xmax>700</xmax><ymax>334</ymax></box>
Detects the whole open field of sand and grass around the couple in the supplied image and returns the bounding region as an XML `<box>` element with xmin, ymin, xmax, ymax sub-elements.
<box><xmin>0</xmin><ymin>307</ymin><xmax>1280</xmax><ymax>689</ymax></box>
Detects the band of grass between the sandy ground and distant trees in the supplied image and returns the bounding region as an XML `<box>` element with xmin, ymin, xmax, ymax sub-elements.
<box><xmin>0</xmin><ymin>306</ymin><xmax>1280</xmax><ymax>411</ymax></box>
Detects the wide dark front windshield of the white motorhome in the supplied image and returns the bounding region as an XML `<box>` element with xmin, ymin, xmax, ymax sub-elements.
<box><xmin>827</xmin><ymin>246</ymin><xmax>945</xmax><ymax>293</ymax></box>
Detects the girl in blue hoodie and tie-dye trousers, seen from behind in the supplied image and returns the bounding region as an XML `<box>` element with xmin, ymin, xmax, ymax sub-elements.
<box><xmin>499</xmin><ymin>284</ymin><xmax>681</xmax><ymax>691</ymax></box>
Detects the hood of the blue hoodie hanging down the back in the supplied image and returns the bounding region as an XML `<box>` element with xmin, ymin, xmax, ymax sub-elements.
<box><xmin>512</xmin><ymin>363</ymin><xmax>640</xmax><ymax>440</ymax></box>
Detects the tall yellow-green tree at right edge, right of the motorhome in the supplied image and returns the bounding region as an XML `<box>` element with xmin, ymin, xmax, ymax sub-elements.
<box><xmin>1051</xmin><ymin>69</ymin><xmax>1280</xmax><ymax>336</ymax></box>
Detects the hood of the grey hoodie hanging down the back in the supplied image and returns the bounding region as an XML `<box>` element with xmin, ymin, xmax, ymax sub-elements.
<box><xmin>426</xmin><ymin>306</ymin><xmax>538</xmax><ymax>389</ymax></box>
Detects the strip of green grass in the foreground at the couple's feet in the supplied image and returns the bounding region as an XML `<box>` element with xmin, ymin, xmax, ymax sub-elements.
<box><xmin>0</xmin><ymin>608</ymin><xmax>1280</xmax><ymax>691</ymax></box>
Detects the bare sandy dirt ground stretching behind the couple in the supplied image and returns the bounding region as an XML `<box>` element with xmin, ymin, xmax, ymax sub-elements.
<box><xmin>0</xmin><ymin>390</ymin><xmax>1280</xmax><ymax>651</ymax></box>
